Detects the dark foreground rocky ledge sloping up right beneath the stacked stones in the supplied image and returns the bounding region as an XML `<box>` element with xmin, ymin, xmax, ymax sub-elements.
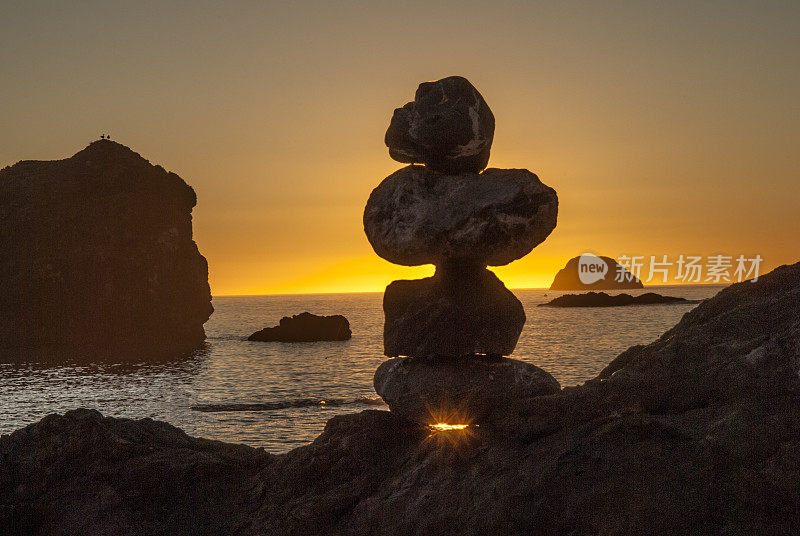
<box><xmin>0</xmin><ymin>264</ymin><xmax>800</xmax><ymax>535</ymax></box>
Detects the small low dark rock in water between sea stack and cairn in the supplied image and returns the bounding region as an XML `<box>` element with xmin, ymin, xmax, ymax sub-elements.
<box><xmin>247</xmin><ymin>313</ymin><xmax>353</xmax><ymax>342</ymax></box>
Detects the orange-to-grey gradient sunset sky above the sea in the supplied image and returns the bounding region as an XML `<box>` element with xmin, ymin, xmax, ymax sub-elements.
<box><xmin>0</xmin><ymin>0</ymin><xmax>800</xmax><ymax>295</ymax></box>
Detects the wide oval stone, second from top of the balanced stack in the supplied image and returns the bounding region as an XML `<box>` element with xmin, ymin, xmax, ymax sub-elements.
<box><xmin>364</xmin><ymin>166</ymin><xmax>558</xmax><ymax>266</ymax></box>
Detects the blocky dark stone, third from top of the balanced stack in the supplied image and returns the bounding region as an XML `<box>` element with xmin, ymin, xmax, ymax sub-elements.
<box><xmin>383</xmin><ymin>266</ymin><xmax>525</xmax><ymax>357</ymax></box>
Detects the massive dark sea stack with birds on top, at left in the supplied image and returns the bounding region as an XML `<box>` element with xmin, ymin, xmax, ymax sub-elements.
<box><xmin>0</xmin><ymin>140</ymin><xmax>213</xmax><ymax>361</ymax></box>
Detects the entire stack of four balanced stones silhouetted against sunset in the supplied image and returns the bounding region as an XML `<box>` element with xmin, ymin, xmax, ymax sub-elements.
<box><xmin>364</xmin><ymin>76</ymin><xmax>560</xmax><ymax>424</ymax></box>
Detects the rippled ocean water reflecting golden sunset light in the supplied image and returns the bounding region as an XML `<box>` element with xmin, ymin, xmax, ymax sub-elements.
<box><xmin>0</xmin><ymin>286</ymin><xmax>720</xmax><ymax>453</ymax></box>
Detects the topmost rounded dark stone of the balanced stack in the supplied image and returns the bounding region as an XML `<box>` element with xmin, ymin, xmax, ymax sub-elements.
<box><xmin>385</xmin><ymin>76</ymin><xmax>494</xmax><ymax>173</ymax></box>
